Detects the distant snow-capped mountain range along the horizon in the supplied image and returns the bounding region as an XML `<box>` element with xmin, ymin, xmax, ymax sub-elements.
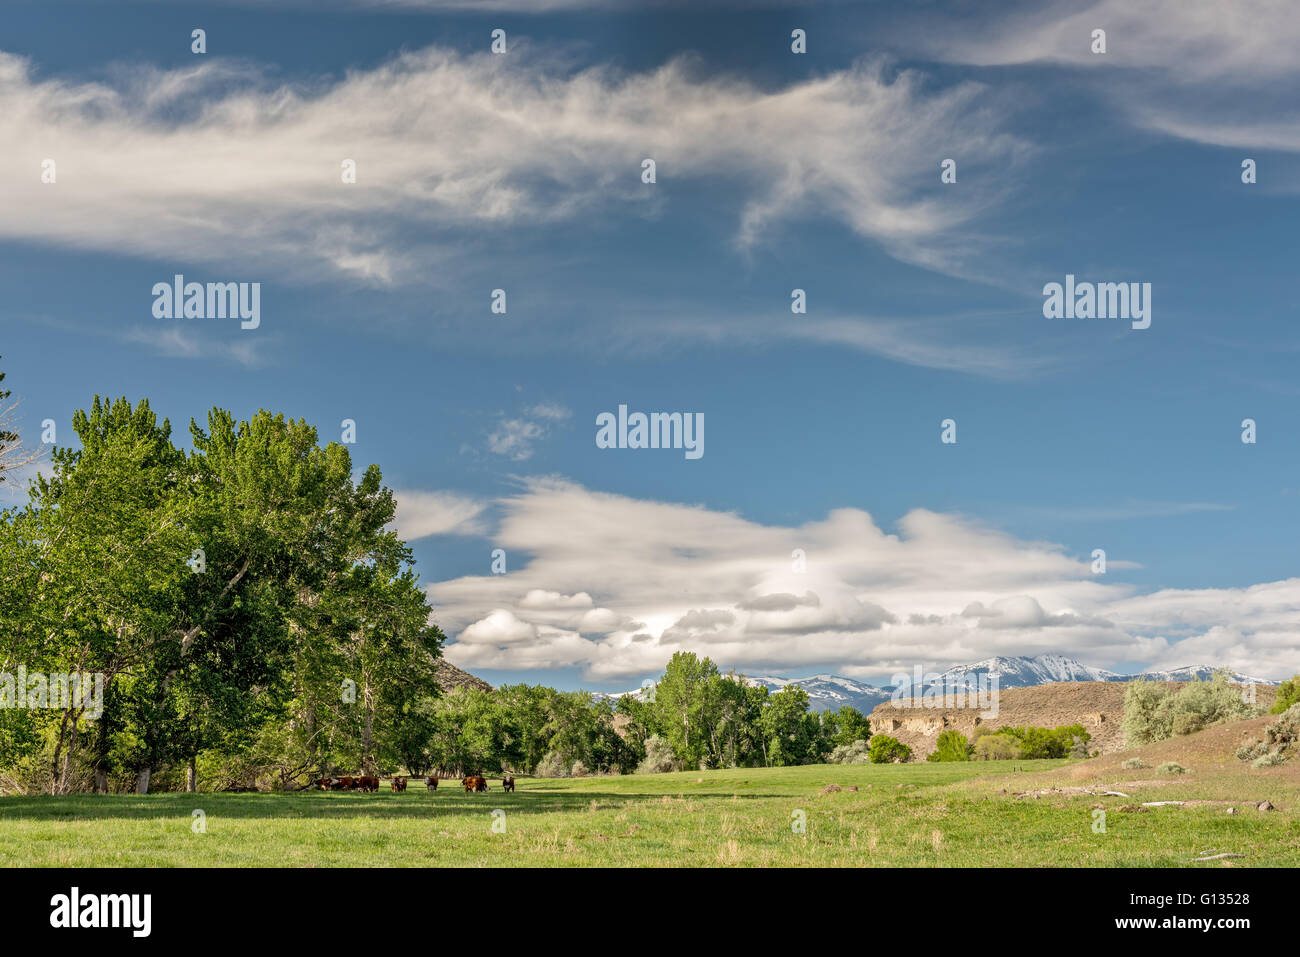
<box><xmin>594</xmin><ymin>654</ymin><xmax>1277</xmax><ymax>714</ymax></box>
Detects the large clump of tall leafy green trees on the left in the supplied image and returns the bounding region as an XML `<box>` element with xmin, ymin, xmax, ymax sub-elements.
<box><xmin>0</xmin><ymin>397</ymin><xmax>443</xmax><ymax>792</ymax></box>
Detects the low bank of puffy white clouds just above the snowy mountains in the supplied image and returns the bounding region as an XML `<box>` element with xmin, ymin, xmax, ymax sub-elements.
<box><xmin>429</xmin><ymin>479</ymin><xmax>1300</xmax><ymax>681</ymax></box>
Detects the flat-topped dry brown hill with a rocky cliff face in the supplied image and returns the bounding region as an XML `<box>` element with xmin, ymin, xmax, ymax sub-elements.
<box><xmin>871</xmin><ymin>681</ymin><xmax>1275</xmax><ymax>761</ymax></box>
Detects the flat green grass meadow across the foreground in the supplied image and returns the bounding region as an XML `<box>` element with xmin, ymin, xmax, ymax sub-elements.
<box><xmin>0</xmin><ymin>761</ymin><xmax>1300</xmax><ymax>867</ymax></box>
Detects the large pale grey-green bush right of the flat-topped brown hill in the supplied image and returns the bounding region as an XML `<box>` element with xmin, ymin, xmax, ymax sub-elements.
<box><xmin>1122</xmin><ymin>671</ymin><xmax>1260</xmax><ymax>748</ymax></box>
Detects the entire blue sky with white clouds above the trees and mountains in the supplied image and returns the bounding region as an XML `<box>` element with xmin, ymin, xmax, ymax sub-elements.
<box><xmin>0</xmin><ymin>0</ymin><xmax>1300</xmax><ymax>690</ymax></box>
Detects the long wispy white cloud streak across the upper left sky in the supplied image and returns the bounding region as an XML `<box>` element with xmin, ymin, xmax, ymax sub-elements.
<box><xmin>0</xmin><ymin>43</ymin><xmax>1026</xmax><ymax>283</ymax></box>
